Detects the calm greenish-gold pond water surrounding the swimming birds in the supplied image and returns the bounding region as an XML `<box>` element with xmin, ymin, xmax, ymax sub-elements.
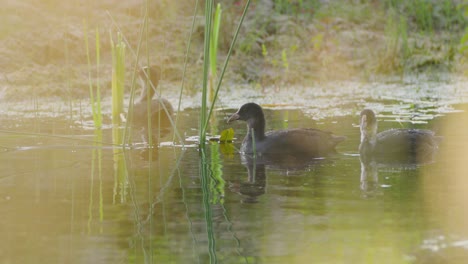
<box><xmin>0</xmin><ymin>79</ymin><xmax>468</xmax><ymax>263</ymax></box>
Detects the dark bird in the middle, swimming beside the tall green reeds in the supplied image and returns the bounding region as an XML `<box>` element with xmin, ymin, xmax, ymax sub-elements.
<box><xmin>228</xmin><ymin>103</ymin><xmax>346</xmax><ymax>159</ymax></box>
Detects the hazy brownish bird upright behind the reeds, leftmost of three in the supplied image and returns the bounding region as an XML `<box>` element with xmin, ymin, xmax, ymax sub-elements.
<box><xmin>132</xmin><ymin>66</ymin><xmax>174</xmax><ymax>142</ymax></box>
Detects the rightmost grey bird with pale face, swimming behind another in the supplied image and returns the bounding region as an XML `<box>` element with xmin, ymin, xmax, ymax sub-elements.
<box><xmin>359</xmin><ymin>109</ymin><xmax>441</xmax><ymax>163</ymax></box>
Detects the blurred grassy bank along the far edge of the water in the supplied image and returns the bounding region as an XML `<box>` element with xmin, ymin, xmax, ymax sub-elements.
<box><xmin>0</xmin><ymin>0</ymin><xmax>468</xmax><ymax>100</ymax></box>
